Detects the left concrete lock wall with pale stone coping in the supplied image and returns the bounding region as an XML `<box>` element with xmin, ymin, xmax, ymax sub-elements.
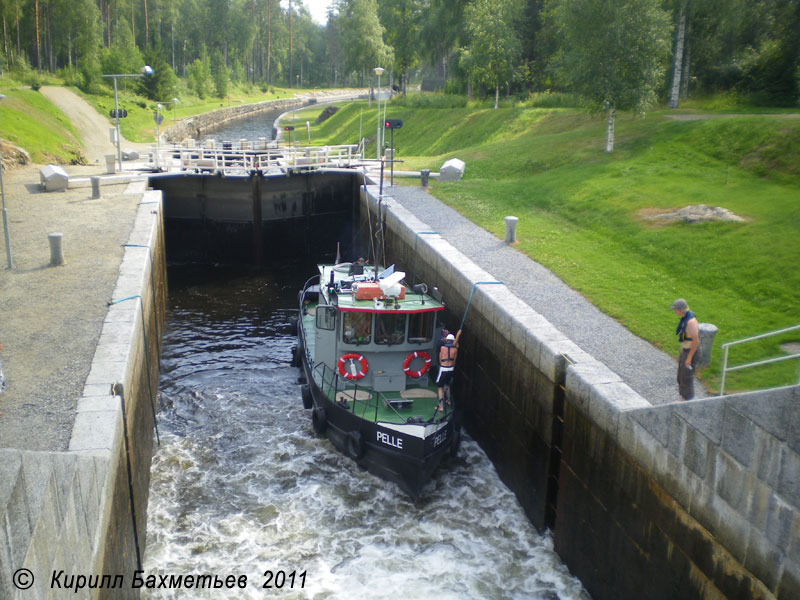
<box><xmin>0</xmin><ymin>182</ymin><xmax>166</xmax><ymax>599</ymax></box>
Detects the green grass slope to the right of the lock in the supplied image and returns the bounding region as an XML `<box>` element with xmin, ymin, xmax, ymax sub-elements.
<box><xmin>303</xmin><ymin>98</ymin><xmax>800</xmax><ymax>391</ymax></box>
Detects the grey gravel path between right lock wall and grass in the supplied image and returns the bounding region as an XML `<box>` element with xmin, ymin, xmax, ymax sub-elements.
<box><xmin>384</xmin><ymin>187</ymin><xmax>706</xmax><ymax>404</ymax></box>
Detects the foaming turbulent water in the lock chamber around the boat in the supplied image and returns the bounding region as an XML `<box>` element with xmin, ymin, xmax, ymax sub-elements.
<box><xmin>144</xmin><ymin>268</ymin><xmax>589</xmax><ymax>600</ymax></box>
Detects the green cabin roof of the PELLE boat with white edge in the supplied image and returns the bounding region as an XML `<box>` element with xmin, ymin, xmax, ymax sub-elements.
<box><xmin>319</xmin><ymin>263</ymin><xmax>444</xmax><ymax>314</ymax></box>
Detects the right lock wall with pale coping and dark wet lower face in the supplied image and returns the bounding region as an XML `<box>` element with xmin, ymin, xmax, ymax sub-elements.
<box><xmin>361</xmin><ymin>186</ymin><xmax>800</xmax><ymax>600</ymax></box>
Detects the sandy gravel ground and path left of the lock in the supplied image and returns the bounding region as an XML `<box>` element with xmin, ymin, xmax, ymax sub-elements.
<box><xmin>0</xmin><ymin>88</ymin><xmax>145</xmax><ymax>450</ymax></box>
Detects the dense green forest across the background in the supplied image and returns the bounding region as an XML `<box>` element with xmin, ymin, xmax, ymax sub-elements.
<box><xmin>0</xmin><ymin>0</ymin><xmax>800</xmax><ymax>109</ymax></box>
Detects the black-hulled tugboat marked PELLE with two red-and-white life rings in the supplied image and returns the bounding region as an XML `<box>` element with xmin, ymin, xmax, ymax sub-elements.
<box><xmin>294</xmin><ymin>260</ymin><xmax>461</xmax><ymax>502</ymax></box>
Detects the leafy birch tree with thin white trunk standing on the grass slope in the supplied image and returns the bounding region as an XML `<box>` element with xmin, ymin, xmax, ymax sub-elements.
<box><xmin>555</xmin><ymin>0</ymin><xmax>671</xmax><ymax>152</ymax></box>
